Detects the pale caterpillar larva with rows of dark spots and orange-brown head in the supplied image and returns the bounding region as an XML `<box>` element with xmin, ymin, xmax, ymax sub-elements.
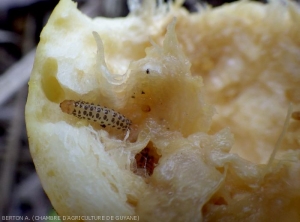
<box><xmin>60</xmin><ymin>100</ymin><xmax>131</xmax><ymax>130</ymax></box>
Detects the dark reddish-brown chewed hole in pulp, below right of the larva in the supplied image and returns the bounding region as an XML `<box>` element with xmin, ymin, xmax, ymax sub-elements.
<box><xmin>134</xmin><ymin>142</ymin><xmax>161</xmax><ymax>176</ymax></box>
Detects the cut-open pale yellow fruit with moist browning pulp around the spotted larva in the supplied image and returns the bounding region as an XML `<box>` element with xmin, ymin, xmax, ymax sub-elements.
<box><xmin>26</xmin><ymin>0</ymin><xmax>300</xmax><ymax>221</ymax></box>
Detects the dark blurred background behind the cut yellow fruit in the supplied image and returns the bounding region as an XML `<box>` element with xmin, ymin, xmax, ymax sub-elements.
<box><xmin>0</xmin><ymin>0</ymin><xmax>278</xmax><ymax>221</ymax></box>
